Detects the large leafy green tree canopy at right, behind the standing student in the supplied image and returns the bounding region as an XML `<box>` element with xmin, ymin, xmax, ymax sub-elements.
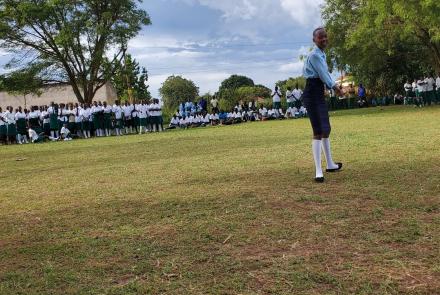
<box><xmin>323</xmin><ymin>0</ymin><xmax>440</xmax><ymax>95</ymax></box>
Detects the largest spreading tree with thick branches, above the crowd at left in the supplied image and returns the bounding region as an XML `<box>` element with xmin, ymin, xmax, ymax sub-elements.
<box><xmin>0</xmin><ymin>0</ymin><xmax>151</xmax><ymax>102</ymax></box>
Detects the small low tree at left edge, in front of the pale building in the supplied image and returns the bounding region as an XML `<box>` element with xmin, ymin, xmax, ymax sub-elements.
<box><xmin>0</xmin><ymin>71</ymin><xmax>43</xmax><ymax>108</ymax></box>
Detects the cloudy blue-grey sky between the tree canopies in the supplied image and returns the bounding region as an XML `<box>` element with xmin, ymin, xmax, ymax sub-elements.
<box><xmin>0</xmin><ymin>0</ymin><xmax>323</xmax><ymax>96</ymax></box>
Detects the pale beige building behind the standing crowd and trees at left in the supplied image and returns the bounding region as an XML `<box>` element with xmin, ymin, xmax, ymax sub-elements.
<box><xmin>0</xmin><ymin>83</ymin><xmax>117</xmax><ymax>109</ymax></box>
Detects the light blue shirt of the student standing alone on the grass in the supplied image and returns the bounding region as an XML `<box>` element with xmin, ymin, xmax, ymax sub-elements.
<box><xmin>303</xmin><ymin>46</ymin><xmax>336</xmax><ymax>89</ymax></box>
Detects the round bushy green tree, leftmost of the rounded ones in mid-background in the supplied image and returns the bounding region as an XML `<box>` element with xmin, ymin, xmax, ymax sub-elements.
<box><xmin>159</xmin><ymin>76</ymin><xmax>199</xmax><ymax>111</ymax></box>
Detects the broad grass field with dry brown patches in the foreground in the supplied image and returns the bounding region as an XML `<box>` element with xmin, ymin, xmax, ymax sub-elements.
<box><xmin>0</xmin><ymin>107</ymin><xmax>440</xmax><ymax>294</ymax></box>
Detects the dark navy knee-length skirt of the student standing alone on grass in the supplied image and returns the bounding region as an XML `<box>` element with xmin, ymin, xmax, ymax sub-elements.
<box><xmin>303</xmin><ymin>78</ymin><xmax>331</xmax><ymax>136</ymax></box>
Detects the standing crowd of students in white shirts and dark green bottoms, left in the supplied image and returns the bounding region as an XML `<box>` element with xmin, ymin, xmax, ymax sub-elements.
<box><xmin>0</xmin><ymin>99</ymin><xmax>164</xmax><ymax>144</ymax></box>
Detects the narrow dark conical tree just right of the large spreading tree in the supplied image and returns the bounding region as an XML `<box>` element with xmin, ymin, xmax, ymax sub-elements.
<box><xmin>111</xmin><ymin>54</ymin><xmax>151</xmax><ymax>103</ymax></box>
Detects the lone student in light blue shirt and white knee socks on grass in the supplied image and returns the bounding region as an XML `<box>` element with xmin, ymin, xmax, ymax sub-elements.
<box><xmin>303</xmin><ymin>27</ymin><xmax>343</xmax><ymax>182</ymax></box>
